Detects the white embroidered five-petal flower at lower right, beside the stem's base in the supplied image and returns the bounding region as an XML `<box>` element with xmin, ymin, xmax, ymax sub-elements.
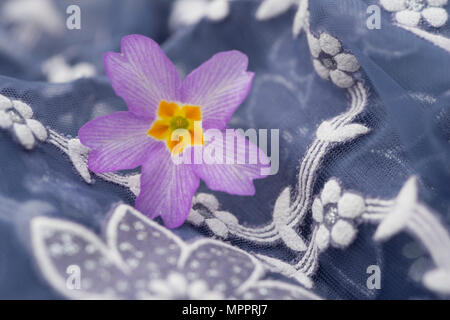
<box><xmin>312</xmin><ymin>179</ymin><xmax>366</xmax><ymax>251</ymax></box>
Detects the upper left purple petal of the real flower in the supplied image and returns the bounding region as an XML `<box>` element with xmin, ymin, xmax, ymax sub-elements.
<box><xmin>104</xmin><ymin>35</ymin><xmax>181</xmax><ymax>119</ymax></box>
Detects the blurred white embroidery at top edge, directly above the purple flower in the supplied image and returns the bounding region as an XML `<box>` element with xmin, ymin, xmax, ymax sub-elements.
<box><xmin>169</xmin><ymin>0</ymin><xmax>230</xmax><ymax>30</ymax></box>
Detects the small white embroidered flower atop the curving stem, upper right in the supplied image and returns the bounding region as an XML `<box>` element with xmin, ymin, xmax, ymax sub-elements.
<box><xmin>308</xmin><ymin>32</ymin><xmax>360</xmax><ymax>88</ymax></box>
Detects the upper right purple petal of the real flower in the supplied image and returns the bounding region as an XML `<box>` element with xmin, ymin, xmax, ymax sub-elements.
<box><xmin>182</xmin><ymin>51</ymin><xmax>254</xmax><ymax>129</ymax></box>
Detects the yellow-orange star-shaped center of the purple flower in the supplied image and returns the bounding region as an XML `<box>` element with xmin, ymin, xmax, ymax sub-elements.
<box><xmin>147</xmin><ymin>100</ymin><xmax>204</xmax><ymax>155</ymax></box>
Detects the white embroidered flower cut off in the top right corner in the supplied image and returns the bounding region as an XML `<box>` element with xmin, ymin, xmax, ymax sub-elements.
<box><xmin>381</xmin><ymin>0</ymin><xmax>448</xmax><ymax>28</ymax></box>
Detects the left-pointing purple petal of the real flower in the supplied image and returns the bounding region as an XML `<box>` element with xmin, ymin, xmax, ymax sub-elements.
<box><xmin>78</xmin><ymin>111</ymin><xmax>160</xmax><ymax>173</ymax></box>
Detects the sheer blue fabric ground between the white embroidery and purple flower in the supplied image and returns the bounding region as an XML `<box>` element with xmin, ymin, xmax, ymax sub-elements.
<box><xmin>0</xmin><ymin>0</ymin><xmax>450</xmax><ymax>299</ymax></box>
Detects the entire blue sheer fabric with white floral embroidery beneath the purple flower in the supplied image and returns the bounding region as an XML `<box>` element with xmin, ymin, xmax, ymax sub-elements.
<box><xmin>0</xmin><ymin>0</ymin><xmax>450</xmax><ymax>299</ymax></box>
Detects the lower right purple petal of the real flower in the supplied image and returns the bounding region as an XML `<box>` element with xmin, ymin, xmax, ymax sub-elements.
<box><xmin>195</xmin><ymin>131</ymin><xmax>270</xmax><ymax>195</ymax></box>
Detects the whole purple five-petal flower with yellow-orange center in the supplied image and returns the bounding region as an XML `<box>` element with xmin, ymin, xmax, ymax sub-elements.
<box><xmin>78</xmin><ymin>35</ymin><xmax>269</xmax><ymax>228</ymax></box>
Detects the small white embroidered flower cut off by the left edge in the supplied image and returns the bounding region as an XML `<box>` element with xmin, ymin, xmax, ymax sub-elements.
<box><xmin>0</xmin><ymin>95</ymin><xmax>48</xmax><ymax>150</ymax></box>
